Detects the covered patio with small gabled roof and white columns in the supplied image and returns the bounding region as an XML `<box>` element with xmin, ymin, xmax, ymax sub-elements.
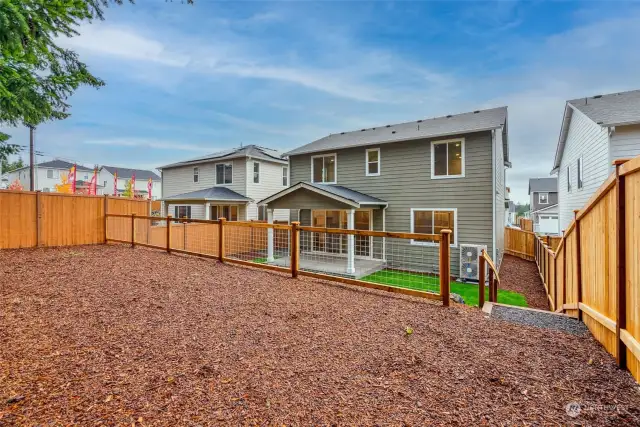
<box><xmin>258</xmin><ymin>182</ymin><xmax>387</xmax><ymax>278</ymax></box>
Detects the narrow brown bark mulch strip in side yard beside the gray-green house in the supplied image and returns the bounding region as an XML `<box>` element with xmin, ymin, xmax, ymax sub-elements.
<box><xmin>500</xmin><ymin>255</ymin><xmax>549</xmax><ymax>310</ymax></box>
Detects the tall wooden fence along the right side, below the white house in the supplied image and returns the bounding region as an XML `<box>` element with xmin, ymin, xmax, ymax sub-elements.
<box><xmin>534</xmin><ymin>156</ymin><xmax>640</xmax><ymax>380</ymax></box>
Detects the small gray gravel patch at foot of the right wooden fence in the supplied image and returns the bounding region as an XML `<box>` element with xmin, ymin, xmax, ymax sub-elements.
<box><xmin>491</xmin><ymin>305</ymin><xmax>589</xmax><ymax>335</ymax></box>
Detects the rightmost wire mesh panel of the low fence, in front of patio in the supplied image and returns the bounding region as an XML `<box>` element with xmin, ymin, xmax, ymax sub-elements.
<box><xmin>300</xmin><ymin>230</ymin><xmax>440</xmax><ymax>293</ymax></box>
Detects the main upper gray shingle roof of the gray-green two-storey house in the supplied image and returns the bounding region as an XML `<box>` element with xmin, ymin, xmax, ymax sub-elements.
<box><xmin>285</xmin><ymin>107</ymin><xmax>509</xmax><ymax>161</ymax></box>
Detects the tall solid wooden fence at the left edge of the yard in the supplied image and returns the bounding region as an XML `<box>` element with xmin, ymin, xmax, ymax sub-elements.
<box><xmin>0</xmin><ymin>190</ymin><xmax>149</xmax><ymax>249</ymax></box>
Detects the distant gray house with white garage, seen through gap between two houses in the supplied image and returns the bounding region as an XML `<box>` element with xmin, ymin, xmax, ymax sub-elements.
<box><xmin>527</xmin><ymin>178</ymin><xmax>560</xmax><ymax>234</ymax></box>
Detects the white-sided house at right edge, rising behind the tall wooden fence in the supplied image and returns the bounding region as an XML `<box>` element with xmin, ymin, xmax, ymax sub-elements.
<box><xmin>551</xmin><ymin>90</ymin><xmax>640</xmax><ymax>230</ymax></box>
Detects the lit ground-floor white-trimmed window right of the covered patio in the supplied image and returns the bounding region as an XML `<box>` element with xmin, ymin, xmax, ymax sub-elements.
<box><xmin>411</xmin><ymin>208</ymin><xmax>458</xmax><ymax>247</ymax></box>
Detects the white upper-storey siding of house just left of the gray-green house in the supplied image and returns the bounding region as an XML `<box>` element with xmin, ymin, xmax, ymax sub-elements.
<box><xmin>162</xmin><ymin>159</ymin><xmax>246</xmax><ymax>197</ymax></box>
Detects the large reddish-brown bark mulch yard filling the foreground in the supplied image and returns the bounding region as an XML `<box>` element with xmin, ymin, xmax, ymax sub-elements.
<box><xmin>0</xmin><ymin>245</ymin><xmax>640</xmax><ymax>426</ymax></box>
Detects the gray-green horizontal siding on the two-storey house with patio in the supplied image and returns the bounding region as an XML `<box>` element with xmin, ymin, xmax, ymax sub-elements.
<box><xmin>290</xmin><ymin>132</ymin><xmax>496</xmax><ymax>275</ymax></box>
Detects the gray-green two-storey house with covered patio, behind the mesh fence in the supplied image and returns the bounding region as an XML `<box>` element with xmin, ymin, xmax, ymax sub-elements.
<box><xmin>260</xmin><ymin>107</ymin><xmax>509</xmax><ymax>275</ymax></box>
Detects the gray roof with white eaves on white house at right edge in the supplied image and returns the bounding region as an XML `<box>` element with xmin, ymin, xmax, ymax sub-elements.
<box><xmin>551</xmin><ymin>90</ymin><xmax>640</xmax><ymax>173</ymax></box>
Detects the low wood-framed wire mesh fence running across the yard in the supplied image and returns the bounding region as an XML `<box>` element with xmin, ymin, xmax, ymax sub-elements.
<box><xmin>104</xmin><ymin>213</ymin><xmax>456</xmax><ymax>306</ymax></box>
